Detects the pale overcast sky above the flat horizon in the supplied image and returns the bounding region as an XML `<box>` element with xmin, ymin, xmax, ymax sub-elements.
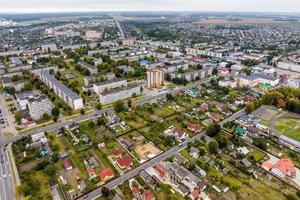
<box><xmin>0</xmin><ymin>0</ymin><xmax>300</xmax><ymax>13</ymax></box>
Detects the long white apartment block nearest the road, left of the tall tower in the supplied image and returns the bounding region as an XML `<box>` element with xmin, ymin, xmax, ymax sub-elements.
<box><xmin>99</xmin><ymin>85</ymin><xmax>142</xmax><ymax>105</ymax></box>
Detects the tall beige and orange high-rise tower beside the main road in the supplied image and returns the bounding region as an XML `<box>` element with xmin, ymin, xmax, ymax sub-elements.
<box><xmin>147</xmin><ymin>69</ymin><xmax>164</xmax><ymax>88</ymax></box>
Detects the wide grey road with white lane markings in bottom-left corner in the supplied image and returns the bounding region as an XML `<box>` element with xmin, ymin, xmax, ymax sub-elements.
<box><xmin>0</xmin><ymin>147</ymin><xmax>15</xmax><ymax>200</ymax></box>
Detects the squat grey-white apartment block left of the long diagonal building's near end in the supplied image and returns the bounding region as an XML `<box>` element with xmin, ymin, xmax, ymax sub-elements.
<box><xmin>27</xmin><ymin>94</ymin><xmax>53</xmax><ymax>120</ymax></box>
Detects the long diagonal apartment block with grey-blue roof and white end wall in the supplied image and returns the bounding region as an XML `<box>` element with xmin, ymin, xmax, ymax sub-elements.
<box><xmin>40</xmin><ymin>71</ymin><xmax>83</xmax><ymax>110</ymax></box>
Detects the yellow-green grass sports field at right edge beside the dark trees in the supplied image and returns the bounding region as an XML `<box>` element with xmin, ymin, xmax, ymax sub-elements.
<box><xmin>274</xmin><ymin>118</ymin><xmax>300</xmax><ymax>141</ymax></box>
